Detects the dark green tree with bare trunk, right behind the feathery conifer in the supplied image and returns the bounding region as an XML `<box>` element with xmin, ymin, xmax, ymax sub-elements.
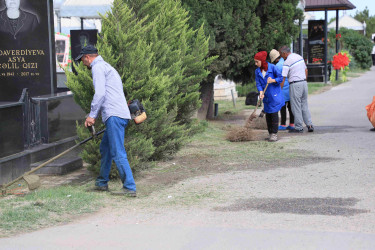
<box><xmin>182</xmin><ymin>0</ymin><xmax>260</xmax><ymax>118</ymax></box>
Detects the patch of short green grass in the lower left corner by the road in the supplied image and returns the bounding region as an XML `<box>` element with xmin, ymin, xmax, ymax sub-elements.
<box><xmin>0</xmin><ymin>186</ymin><xmax>103</xmax><ymax>237</ymax></box>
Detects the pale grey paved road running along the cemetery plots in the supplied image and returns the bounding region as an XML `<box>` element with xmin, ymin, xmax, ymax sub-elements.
<box><xmin>0</xmin><ymin>68</ymin><xmax>375</xmax><ymax>249</ymax></box>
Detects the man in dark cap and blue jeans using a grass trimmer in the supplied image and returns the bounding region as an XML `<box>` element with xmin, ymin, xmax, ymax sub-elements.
<box><xmin>75</xmin><ymin>45</ymin><xmax>136</xmax><ymax>197</ymax></box>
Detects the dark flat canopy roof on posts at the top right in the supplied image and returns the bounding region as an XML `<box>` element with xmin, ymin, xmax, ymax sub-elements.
<box><xmin>305</xmin><ymin>0</ymin><xmax>356</xmax><ymax>11</ymax></box>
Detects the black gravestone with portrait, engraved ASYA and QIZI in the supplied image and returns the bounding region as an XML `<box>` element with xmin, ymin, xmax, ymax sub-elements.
<box><xmin>0</xmin><ymin>0</ymin><xmax>56</xmax><ymax>102</ymax></box>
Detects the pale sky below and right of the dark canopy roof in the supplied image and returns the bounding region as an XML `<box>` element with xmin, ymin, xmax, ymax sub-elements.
<box><xmin>311</xmin><ymin>0</ymin><xmax>375</xmax><ymax>21</ymax></box>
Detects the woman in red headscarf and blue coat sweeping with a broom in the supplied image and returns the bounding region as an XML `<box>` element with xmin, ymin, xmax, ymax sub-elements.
<box><xmin>254</xmin><ymin>51</ymin><xmax>285</xmax><ymax>142</ymax></box>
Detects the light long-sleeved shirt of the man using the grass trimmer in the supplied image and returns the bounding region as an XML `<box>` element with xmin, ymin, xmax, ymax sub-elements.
<box><xmin>89</xmin><ymin>56</ymin><xmax>131</xmax><ymax>122</ymax></box>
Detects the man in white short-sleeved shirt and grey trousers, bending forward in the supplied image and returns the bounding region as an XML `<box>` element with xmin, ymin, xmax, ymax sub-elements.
<box><xmin>279</xmin><ymin>46</ymin><xmax>314</xmax><ymax>133</ymax></box>
